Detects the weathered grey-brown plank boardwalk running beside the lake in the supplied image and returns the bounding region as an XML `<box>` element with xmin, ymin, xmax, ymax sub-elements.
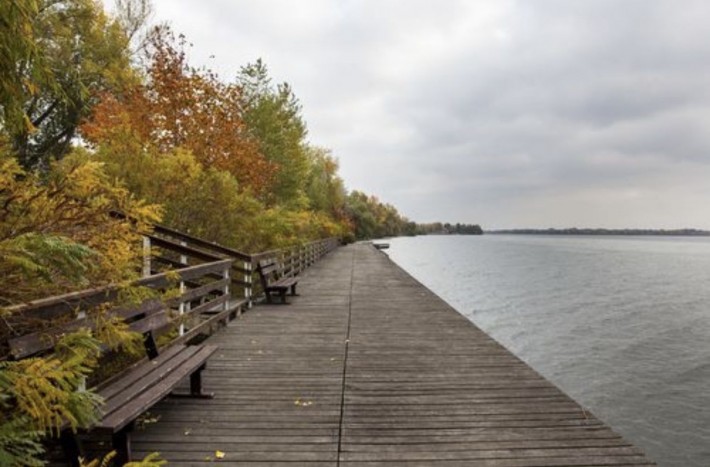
<box><xmin>134</xmin><ymin>245</ymin><xmax>653</xmax><ymax>467</ymax></box>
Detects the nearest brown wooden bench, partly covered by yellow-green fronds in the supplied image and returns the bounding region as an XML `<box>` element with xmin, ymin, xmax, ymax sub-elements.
<box><xmin>8</xmin><ymin>300</ymin><xmax>217</xmax><ymax>466</ymax></box>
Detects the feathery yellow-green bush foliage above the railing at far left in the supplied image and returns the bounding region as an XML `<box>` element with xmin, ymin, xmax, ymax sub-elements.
<box><xmin>0</xmin><ymin>147</ymin><xmax>160</xmax><ymax>305</ymax></box>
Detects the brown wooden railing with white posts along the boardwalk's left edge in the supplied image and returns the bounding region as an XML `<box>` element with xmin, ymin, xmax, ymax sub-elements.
<box><xmin>0</xmin><ymin>226</ymin><xmax>339</xmax><ymax>359</ymax></box>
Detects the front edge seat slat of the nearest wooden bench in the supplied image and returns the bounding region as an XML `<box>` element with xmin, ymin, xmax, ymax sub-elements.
<box><xmin>96</xmin><ymin>345</ymin><xmax>217</xmax><ymax>433</ymax></box>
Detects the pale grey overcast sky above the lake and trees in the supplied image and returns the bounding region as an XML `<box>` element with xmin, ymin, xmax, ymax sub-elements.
<box><xmin>145</xmin><ymin>0</ymin><xmax>710</xmax><ymax>229</ymax></box>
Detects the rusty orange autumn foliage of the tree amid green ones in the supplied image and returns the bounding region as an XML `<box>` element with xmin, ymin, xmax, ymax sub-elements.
<box><xmin>82</xmin><ymin>28</ymin><xmax>277</xmax><ymax>194</ymax></box>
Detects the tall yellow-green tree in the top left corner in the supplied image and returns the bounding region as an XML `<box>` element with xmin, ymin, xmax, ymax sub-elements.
<box><xmin>0</xmin><ymin>0</ymin><xmax>136</xmax><ymax>170</ymax></box>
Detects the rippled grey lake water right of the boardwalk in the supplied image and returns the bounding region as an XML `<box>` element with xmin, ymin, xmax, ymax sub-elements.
<box><xmin>387</xmin><ymin>235</ymin><xmax>710</xmax><ymax>466</ymax></box>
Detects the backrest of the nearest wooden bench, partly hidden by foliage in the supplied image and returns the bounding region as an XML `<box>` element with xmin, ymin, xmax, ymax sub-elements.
<box><xmin>8</xmin><ymin>299</ymin><xmax>170</xmax><ymax>360</ymax></box>
